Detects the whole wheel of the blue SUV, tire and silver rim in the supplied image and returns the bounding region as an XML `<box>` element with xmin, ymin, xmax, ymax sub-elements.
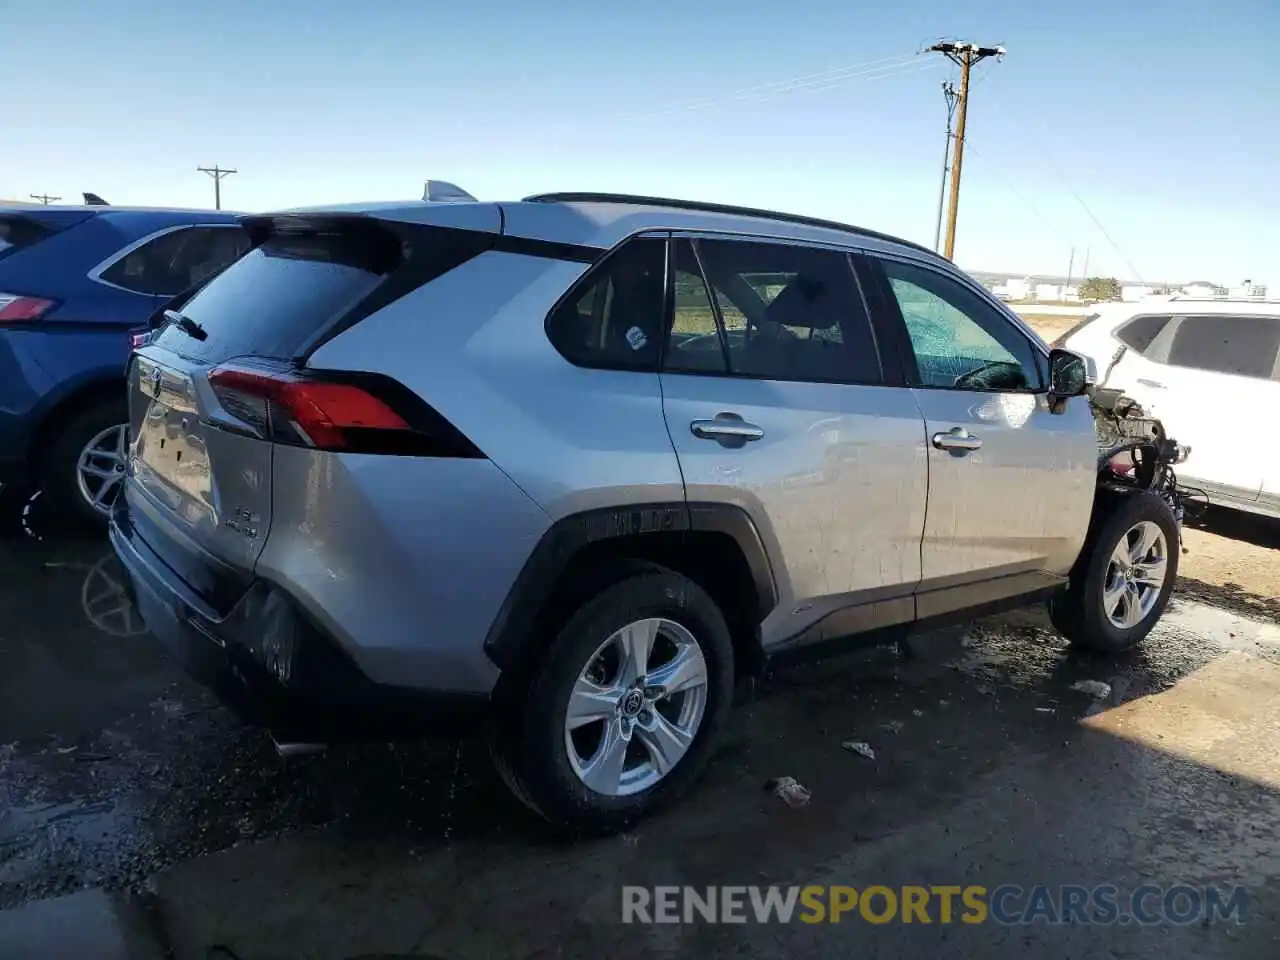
<box><xmin>40</xmin><ymin>398</ymin><xmax>128</xmax><ymax>527</ymax></box>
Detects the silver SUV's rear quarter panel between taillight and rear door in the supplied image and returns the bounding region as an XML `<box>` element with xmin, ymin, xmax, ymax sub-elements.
<box><xmin>310</xmin><ymin>251</ymin><xmax>685</xmax><ymax>520</ymax></box>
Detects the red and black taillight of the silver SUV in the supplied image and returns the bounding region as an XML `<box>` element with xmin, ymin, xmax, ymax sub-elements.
<box><xmin>209</xmin><ymin>364</ymin><xmax>484</xmax><ymax>457</ymax></box>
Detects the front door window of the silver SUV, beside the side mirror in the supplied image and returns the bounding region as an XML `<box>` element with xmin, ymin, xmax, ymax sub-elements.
<box><xmin>881</xmin><ymin>260</ymin><xmax>1041</xmax><ymax>392</ymax></box>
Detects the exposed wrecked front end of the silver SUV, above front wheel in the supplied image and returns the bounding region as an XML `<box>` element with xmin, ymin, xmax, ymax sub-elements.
<box><xmin>1089</xmin><ymin>387</ymin><xmax>1190</xmax><ymax>526</ymax></box>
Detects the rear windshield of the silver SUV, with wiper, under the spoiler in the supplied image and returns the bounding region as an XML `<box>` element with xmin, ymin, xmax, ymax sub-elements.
<box><xmin>156</xmin><ymin>229</ymin><xmax>401</xmax><ymax>362</ymax></box>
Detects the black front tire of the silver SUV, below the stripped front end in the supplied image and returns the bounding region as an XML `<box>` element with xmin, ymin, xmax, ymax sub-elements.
<box><xmin>1050</xmin><ymin>493</ymin><xmax>1180</xmax><ymax>654</ymax></box>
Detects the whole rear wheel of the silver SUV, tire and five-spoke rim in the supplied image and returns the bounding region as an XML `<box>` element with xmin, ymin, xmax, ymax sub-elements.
<box><xmin>494</xmin><ymin>567</ymin><xmax>733</xmax><ymax>832</ymax></box>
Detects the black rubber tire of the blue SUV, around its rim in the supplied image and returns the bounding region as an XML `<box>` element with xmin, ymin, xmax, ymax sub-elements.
<box><xmin>38</xmin><ymin>397</ymin><xmax>129</xmax><ymax>530</ymax></box>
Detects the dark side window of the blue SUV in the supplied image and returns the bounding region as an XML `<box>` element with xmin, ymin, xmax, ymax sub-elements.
<box><xmin>100</xmin><ymin>225</ymin><xmax>250</xmax><ymax>297</ymax></box>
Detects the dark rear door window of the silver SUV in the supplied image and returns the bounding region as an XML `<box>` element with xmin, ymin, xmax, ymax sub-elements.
<box><xmin>664</xmin><ymin>239</ymin><xmax>883</xmax><ymax>384</ymax></box>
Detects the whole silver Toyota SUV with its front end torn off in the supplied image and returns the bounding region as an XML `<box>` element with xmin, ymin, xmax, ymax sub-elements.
<box><xmin>111</xmin><ymin>187</ymin><xmax>1180</xmax><ymax>829</ymax></box>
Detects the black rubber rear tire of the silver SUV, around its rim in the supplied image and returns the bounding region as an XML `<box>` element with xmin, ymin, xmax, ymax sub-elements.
<box><xmin>492</xmin><ymin>564</ymin><xmax>733</xmax><ymax>833</ymax></box>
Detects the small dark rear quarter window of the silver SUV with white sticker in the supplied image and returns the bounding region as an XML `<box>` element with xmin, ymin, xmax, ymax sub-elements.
<box><xmin>547</xmin><ymin>237</ymin><xmax>667</xmax><ymax>370</ymax></box>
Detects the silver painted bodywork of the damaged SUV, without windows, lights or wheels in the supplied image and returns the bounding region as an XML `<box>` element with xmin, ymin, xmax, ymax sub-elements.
<box><xmin>112</xmin><ymin>195</ymin><xmax>1096</xmax><ymax>692</ymax></box>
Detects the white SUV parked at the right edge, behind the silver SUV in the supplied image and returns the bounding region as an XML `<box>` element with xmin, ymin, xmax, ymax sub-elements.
<box><xmin>1053</xmin><ymin>297</ymin><xmax>1280</xmax><ymax>527</ymax></box>
